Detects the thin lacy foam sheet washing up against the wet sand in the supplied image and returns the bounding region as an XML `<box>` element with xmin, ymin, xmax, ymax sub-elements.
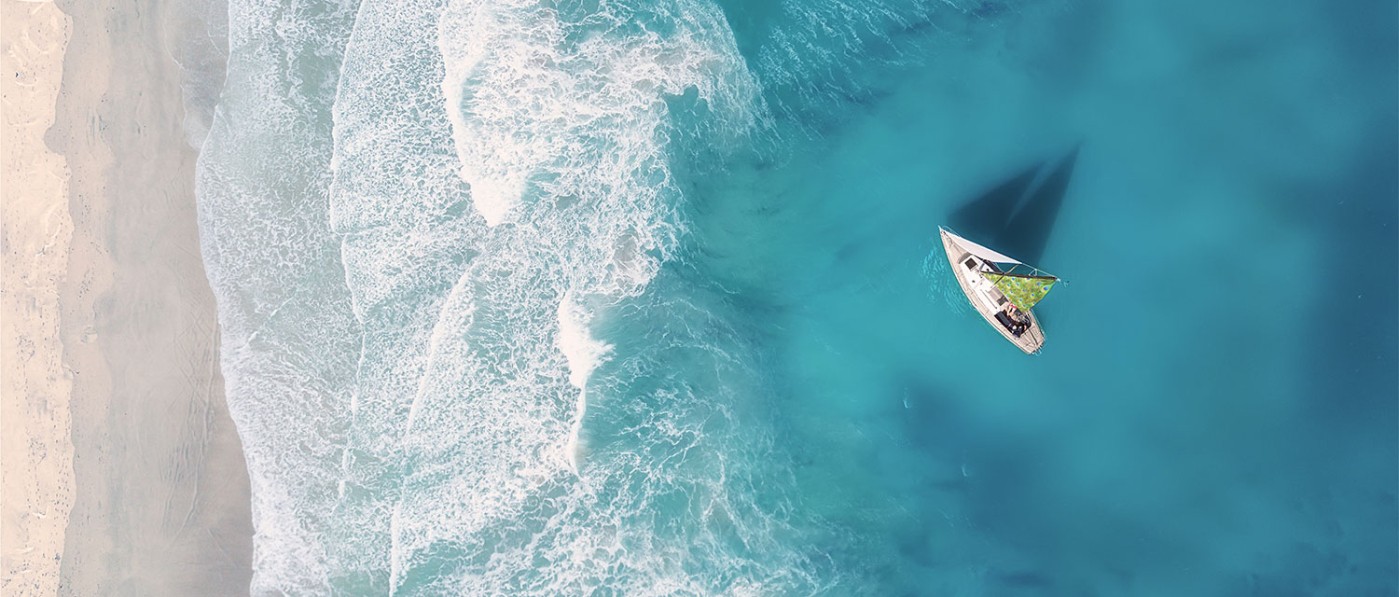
<box><xmin>196</xmin><ymin>0</ymin><xmax>358</xmax><ymax>594</ymax></box>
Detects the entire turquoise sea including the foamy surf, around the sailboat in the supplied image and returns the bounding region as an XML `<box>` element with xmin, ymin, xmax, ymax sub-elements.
<box><xmin>191</xmin><ymin>0</ymin><xmax>1399</xmax><ymax>596</ymax></box>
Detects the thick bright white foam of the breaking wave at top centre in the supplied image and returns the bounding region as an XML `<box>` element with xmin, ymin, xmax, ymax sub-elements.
<box><xmin>438</xmin><ymin>0</ymin><xmax>758</xmax><ymax>294</ymax></box>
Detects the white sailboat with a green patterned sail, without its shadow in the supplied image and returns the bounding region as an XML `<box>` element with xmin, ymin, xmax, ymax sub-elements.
<box><xmin>937</xmin><ymin>226</ymin><xmax>1059</xmax><ymax>355</ymax></box>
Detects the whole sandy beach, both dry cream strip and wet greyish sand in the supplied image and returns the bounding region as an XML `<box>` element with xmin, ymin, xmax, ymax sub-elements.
<box><xmin>0</xmin><ymin>0</ymin><xmax>252</xmax><ymax>596</ymax></box>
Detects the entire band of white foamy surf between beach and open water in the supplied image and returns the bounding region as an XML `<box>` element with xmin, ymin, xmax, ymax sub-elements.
<box><xmin>201</xmin><ymin>0</ymin><xmax>839</xmax><ymax>594</ymax></box>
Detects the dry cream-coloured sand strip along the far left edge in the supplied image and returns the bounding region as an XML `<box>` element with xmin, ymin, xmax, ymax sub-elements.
<box><xmin>0</xmin><ymin>0</ymin><xmax>73</xmax><ymax>596</ymax></box>
